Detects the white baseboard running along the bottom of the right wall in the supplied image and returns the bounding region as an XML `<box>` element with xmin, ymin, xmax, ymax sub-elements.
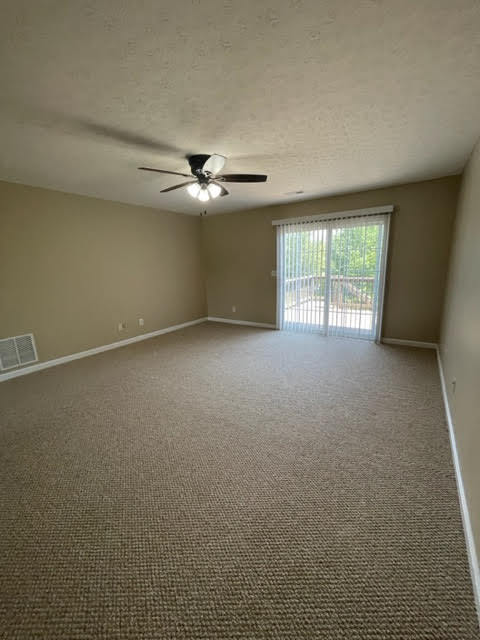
<box><xmin>437</xmin><ymin>347</ymin><xmax>480</xmax><ymax>623</ymax></box>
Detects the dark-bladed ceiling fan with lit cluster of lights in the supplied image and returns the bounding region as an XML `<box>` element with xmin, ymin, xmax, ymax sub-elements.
<box><xmin>138</xmin><ymin>153</ymin><xmax>267</xmax><ymax>202</ymax></box>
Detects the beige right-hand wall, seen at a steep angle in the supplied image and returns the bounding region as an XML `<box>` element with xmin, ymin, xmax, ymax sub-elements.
<box><xmin>440</xmin><ymin>142</ymin><xmax>480</xmax><ymax>557</ymax></box>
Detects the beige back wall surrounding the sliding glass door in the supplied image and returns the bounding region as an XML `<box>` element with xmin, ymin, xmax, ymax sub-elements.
<box><xmin>202</xmin><ymin>176</ymin><xmax>460</xmax><ymax>342</ymax></box>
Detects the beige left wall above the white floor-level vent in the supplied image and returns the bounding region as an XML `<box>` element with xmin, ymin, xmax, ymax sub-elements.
<box><xmin>0</xmin><ymin>182</ymin><xmax>206</xmax><ymax>360</ymax></box>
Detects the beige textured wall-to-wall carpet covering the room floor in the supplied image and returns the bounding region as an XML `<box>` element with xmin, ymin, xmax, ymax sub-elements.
<box><xmin>0</xmin><ymin>324</ymin><xmax>478</xmax><ymax>640</ymax></box>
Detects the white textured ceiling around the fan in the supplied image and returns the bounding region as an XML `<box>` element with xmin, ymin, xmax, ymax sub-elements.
<box><xmin>0</xmin><ymin>0</ymin><xmax>480</xmax><ymax>214</ymax></box>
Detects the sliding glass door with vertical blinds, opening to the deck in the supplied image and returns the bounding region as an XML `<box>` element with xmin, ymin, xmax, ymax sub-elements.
<box><xmin>277</xmin><ymin>215</ymin><xmax>388</xmax><ymax>340</ymax></box>
